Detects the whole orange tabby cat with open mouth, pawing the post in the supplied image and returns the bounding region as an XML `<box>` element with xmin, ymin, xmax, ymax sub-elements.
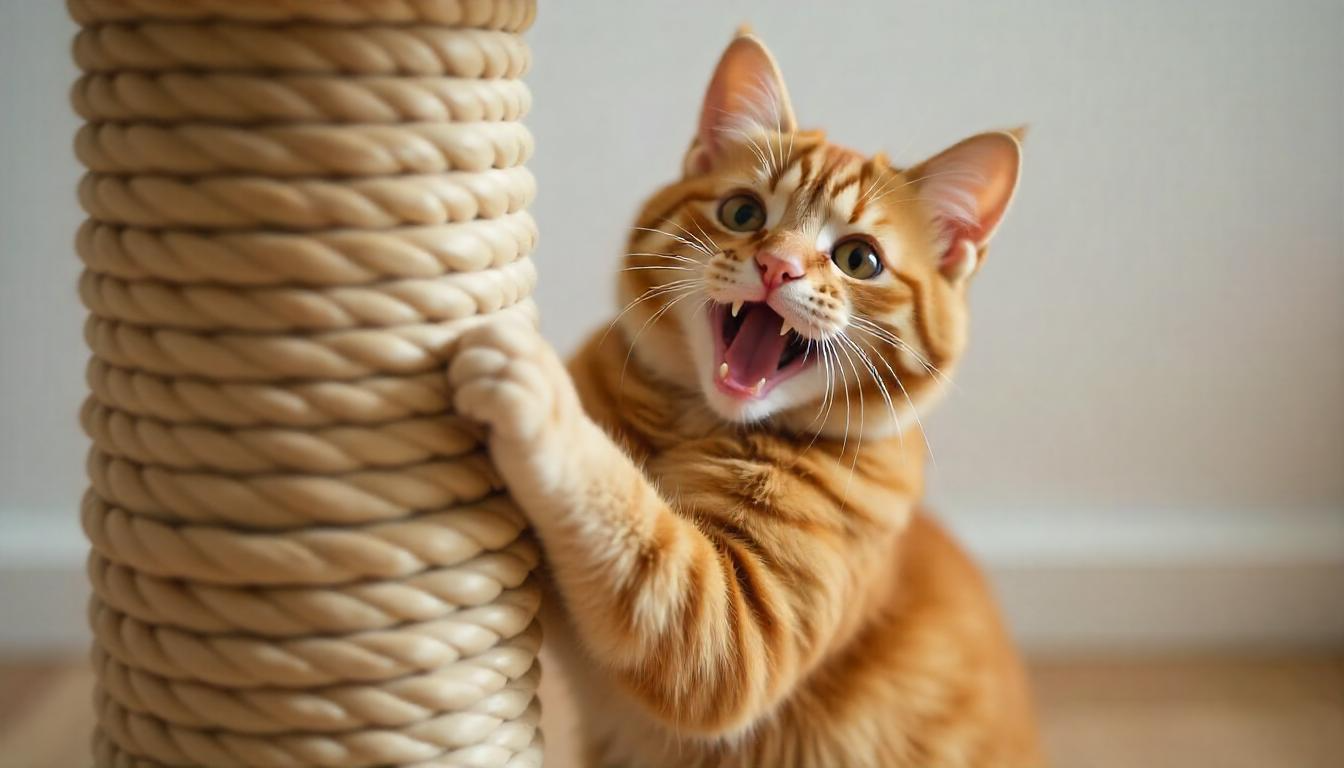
<box><xmin>449</xmin><ymin>28</ymin><xmax>1042</xmax><ymax>768</ymax></box>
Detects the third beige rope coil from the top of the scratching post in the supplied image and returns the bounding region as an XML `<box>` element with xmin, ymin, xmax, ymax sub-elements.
<box><xmin>71</xmin><ymin>71</ymin><xmax>532</xmax><ymax>124</ymax></box>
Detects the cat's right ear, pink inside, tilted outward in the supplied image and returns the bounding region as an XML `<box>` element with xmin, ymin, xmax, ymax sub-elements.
<box><xmin>909</xmin><ymin>128</ymin><xmax>1025</xmax><ymax>282</ymax></box>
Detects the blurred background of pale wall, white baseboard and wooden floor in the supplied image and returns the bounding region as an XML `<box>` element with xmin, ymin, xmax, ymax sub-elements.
<box><xmin>0</xmin><ymin>0</ymin><xmax>1344</xmax><ymax>767</ymax></box>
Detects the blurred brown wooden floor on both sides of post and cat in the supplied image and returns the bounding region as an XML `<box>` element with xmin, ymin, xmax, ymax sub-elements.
<box><xmin>0</xmin><ymin>658</ymin><xmax>1344</xmax><ymax>768</ymax></box>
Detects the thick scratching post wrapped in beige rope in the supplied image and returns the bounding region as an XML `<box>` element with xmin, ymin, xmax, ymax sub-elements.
<box><xmin>69</xmin><ymin>0</ymin><xmax>542</xmax><ymax>768</ymax></box>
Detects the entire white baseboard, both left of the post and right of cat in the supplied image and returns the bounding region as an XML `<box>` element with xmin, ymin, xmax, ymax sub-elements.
<box><xmin>0</xmin><ymin>510</ymin><xmax>1344</xmax><ymax>656</ymax></box>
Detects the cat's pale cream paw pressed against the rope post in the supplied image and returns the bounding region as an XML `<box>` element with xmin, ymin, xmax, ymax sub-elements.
<box><xmin>448</xmin><ymin>319</ymin><xmax>582</xmax><ymax>451</ymax></box>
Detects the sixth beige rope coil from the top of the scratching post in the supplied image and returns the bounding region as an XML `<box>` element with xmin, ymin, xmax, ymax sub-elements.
<box><xmin>75</xmin><ymin>217</ymin><xmax>536</xmax><ymax>286</ymax></box>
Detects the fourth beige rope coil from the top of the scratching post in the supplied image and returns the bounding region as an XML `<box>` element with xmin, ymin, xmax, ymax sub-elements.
<box><xmin>75</xmin><ymin>122</ymin><xmax>532</xmax><ymax>178</ymax></box>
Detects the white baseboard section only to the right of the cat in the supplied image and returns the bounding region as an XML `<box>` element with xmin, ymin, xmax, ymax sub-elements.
<box><xmin>946</xmin><ymin>508</ymin><xmax>1344</xmax><ymax>655</ymax></box>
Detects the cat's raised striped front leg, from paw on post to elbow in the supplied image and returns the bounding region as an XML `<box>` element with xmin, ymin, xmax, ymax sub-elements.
<box><xmin>449</xmin><ymin>321</ymin><xmax>817</xmax><ymax>736</ymax></box>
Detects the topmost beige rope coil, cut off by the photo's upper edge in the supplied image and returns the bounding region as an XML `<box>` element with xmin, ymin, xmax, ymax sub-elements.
<box><xmin>69</xmin><ymin>0</ymin><xmax>536</xmax><ymax>32</ymax></box>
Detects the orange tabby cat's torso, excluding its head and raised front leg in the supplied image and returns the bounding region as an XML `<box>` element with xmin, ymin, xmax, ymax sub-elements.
<box><xmin>546</xmin><ymin>336</ymin><xmax>1040</xmax><ymax>768</ymax></box>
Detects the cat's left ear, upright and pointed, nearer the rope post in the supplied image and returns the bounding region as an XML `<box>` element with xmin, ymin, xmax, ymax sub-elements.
<box><xmin>684</xmin><ymin>26</ymin><xmax>797</xmax><ymax>175</ymax></box>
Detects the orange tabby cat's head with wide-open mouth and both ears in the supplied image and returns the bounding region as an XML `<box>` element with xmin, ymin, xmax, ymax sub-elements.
<box><xmin>618</xmin><ymin>35</ymin><xmax>1020</xmax><ymax>436</ymax></box>
